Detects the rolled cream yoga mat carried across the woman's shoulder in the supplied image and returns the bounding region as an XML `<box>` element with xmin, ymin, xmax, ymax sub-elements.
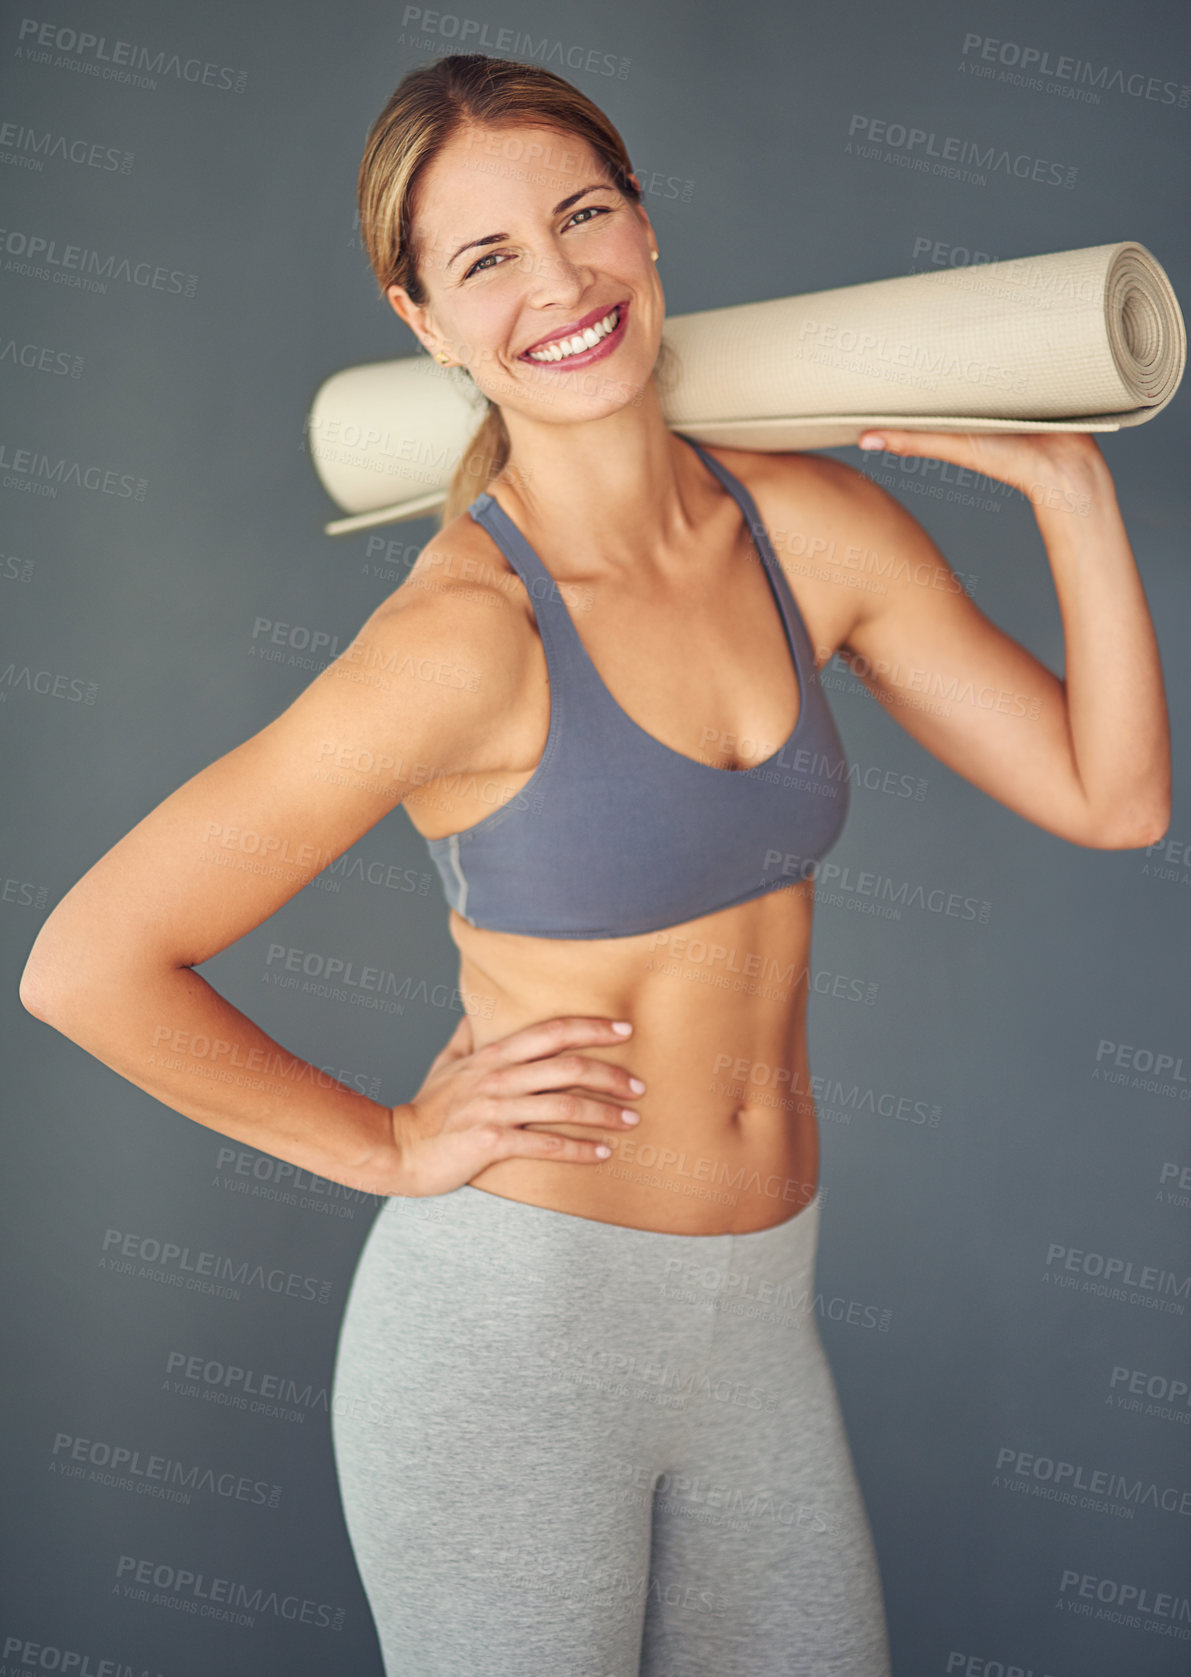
<box><xmin>307</xmin><ymin>240</ymin><xmax>1186</xmax><ymax>535</ymax></box>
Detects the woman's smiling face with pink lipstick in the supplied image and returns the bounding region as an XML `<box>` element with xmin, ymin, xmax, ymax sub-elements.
<box><xmin>387</xmin><ymin>124</ymin><xmax>666</xmax><ymax>423</ymax></box>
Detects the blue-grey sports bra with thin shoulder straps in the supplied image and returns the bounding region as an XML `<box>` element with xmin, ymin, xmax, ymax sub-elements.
<box><xmin>426</xmin><ymin>431</ymin><xmax>849</xmax><ymax>937</ymax></box>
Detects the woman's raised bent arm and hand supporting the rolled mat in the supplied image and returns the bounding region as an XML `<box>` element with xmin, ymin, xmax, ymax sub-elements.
<box><xmin>808</xmin><ymin>428</ymin><xmax>1171</xmax><ymax>850</ymax></box>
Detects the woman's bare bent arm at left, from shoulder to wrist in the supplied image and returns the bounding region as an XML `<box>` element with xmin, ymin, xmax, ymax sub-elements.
<box><xmin>20</xmin><ymin>556</ymin><xmax>634</xmax><ymax>1194</ymax></box>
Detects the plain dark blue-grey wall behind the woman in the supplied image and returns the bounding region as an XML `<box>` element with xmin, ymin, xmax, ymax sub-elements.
<box><xmin>0</xmin><ymin>0</ymin><xmax>1191</xmax><ymax>1677</ymax></box>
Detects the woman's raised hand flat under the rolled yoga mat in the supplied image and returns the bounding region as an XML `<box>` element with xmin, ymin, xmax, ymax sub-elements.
<box><xmin>859</xmin><ymin>426</ymin><xmax>1112</xmax><ymax>505</ymax></box>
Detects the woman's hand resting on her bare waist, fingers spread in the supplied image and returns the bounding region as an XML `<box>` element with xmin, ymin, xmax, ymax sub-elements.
<box><xmin>391</xmin><ymin>1013</ymin><xmax>644</xmax><ymax>1197</ymax></box>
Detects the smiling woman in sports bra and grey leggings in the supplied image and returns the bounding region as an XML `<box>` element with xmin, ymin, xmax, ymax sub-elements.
<box><xmin>22</xmin><ymin>55</ymin><xmax>1169</xmax><ymax>1677</ymax></box>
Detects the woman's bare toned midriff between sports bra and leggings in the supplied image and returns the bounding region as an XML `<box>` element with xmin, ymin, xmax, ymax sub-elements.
<box><xmin>450</xmin><ymin>882</ymin><xmax>819</xmax><ymax>1234</ymax></box>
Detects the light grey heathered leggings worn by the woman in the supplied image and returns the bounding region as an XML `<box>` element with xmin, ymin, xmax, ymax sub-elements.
<box><xmin>332</xmin><ymin>1184</ymin><xmax>889</xmax><ymax>1677</ymax></box>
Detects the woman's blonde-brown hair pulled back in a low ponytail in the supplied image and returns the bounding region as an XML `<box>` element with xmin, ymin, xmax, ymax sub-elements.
<box><xmin>356</xmin><ymin>52</ymin><xmax>666</xmax><ymax>523</ymax></box>
